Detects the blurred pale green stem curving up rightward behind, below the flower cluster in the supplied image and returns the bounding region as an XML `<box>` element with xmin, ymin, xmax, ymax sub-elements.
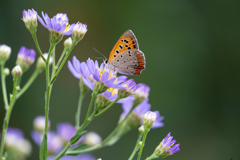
<box><xmin>66</xmin><ymin>104</ymin><xmax>135</xmax><ymax>155</ymax></box>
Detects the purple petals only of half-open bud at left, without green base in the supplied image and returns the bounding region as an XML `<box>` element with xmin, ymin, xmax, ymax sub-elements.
<box><xmin>18</xmin><ymin>46</ymin><xmax>36</xmax><ymax>63</ymax></box>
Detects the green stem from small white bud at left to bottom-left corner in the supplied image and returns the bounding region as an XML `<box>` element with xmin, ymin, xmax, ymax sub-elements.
<box><xmin>0</xmin><ymin>78</ymin><xmax>17</xmax><ymax>158</ymax></box>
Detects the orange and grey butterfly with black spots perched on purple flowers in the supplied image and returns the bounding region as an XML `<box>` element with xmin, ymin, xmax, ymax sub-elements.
<box><xmin>104</xmin><ymin>30</ymin><xmax>146</xmax><ymax>75</ymax></box>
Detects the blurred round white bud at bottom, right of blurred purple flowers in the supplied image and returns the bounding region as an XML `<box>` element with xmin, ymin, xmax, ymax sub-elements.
<box><xmin>84</xmin><ymin>132</ymin><xmax>102</xmax><ymax>147</ymax></box>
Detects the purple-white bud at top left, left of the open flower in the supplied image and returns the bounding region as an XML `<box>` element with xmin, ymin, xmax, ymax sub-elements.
<box><xmin>22</xmin><ymin>9</ymin><xmax>38</xmax><ymax>33</ymax></box>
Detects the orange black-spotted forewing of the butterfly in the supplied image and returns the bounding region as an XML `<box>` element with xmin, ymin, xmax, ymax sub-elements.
<box><xmin>108</xmin><ymin>30</ymin><xmax>139</xmax><ymax>63</ymax></box>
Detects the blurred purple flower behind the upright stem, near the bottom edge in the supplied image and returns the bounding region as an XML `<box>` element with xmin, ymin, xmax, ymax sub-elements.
<box><xmin>31</xmin><ymin>131</ymin><xmax>63</xmax><ymax>154</ymax></box>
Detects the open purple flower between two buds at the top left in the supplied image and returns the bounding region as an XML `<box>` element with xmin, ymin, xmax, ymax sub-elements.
<box><xmin>38</xmin><ymin>12</ymin><xmax>75</xmax><ymax>35</ymax></box>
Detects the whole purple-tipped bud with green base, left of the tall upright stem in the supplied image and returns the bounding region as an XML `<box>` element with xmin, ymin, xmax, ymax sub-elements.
<box><xmin>16</xmin><ymin>46</ymin><xmax>36</xmax><ymax>72</ymax></box>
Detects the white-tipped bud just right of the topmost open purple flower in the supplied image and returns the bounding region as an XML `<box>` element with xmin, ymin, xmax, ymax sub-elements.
<box><xmin>72</xmin><ymin>22</ymin><xmax>87</xmax><ymax>42</ymax></box>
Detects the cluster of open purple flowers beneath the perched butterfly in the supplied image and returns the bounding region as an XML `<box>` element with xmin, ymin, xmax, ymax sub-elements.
<box><xmin>68</xmin><ymin>56</ymin><xmax>164</xmax><ymax>128</ymax></box>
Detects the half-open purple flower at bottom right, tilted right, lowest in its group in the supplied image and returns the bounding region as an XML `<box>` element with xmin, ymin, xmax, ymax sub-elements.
<box><xmin>152</xmin><ymin>133</ymin><xmax>180</xmax><ymax>158</ymax></box>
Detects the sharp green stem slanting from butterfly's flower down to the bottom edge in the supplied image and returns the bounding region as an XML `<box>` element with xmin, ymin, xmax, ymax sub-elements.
<box><xmin>53</xmin><ymin>92</ymin><xmax>98</xmax><ymax>160</ymax></box>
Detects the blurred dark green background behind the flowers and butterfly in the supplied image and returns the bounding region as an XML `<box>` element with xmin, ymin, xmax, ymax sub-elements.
<box><xmin>0</xmin><ymin>0</ymin><xmax>240</xmax><ymax>160</ymax></box>
